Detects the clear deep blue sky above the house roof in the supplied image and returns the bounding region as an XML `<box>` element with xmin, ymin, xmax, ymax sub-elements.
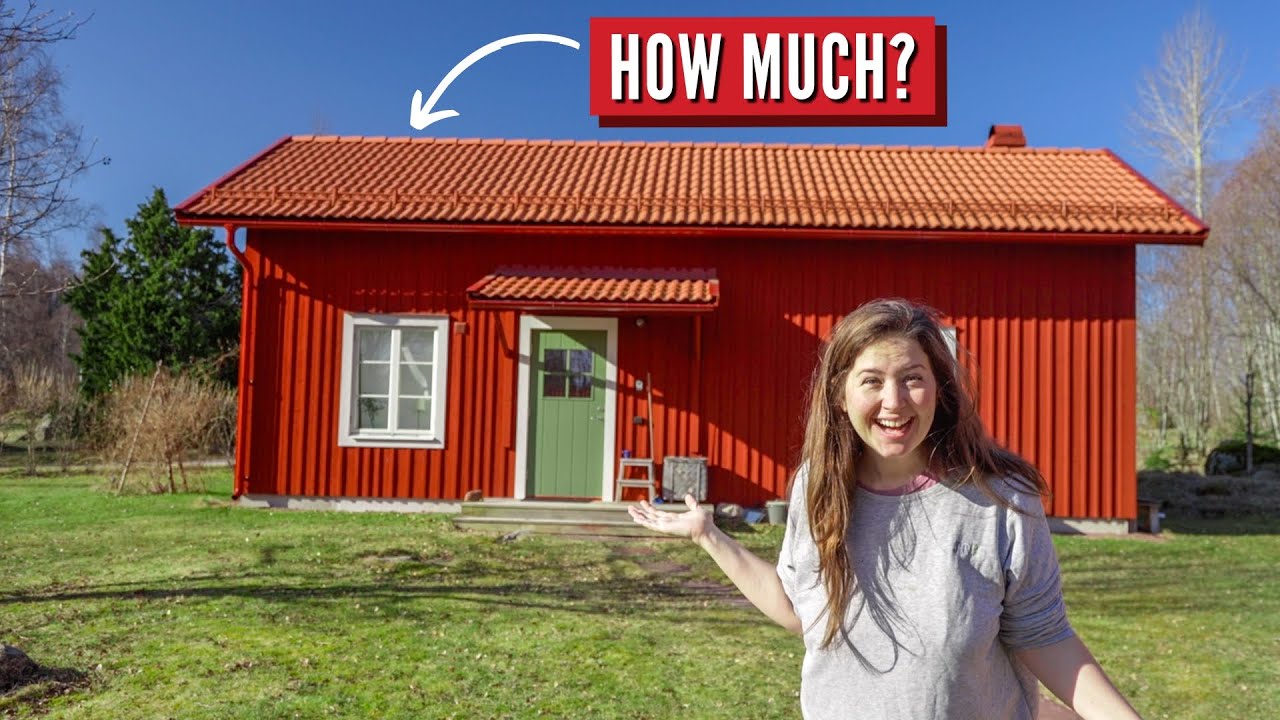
<box><xmin>42</xmin><ymin>0</ymin><xmax>1280</xmax><ymax>255</ymax></box>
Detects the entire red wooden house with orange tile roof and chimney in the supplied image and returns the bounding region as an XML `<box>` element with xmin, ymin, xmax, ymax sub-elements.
<box><xmin>177</xmin><ymin>126</ymin><xmax>1207</xmax><ymax>520</ymax></box>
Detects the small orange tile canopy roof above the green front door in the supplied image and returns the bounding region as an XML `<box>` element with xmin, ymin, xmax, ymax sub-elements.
<box><xmin>467</xmin><ymin>266</ymin><xmax>719</xmax><ymax>311</ymax></box>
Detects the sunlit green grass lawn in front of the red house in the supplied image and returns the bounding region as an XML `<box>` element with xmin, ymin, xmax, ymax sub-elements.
<box><xmin>0</xmin><ymin>471</ymin><xmax>1280</xmax><ymax>719</ymax></box>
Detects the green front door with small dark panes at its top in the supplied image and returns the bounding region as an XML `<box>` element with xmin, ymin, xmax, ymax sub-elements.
<box><xmin>527</xmin><ymin>331</ymin><xmax>608</xmax><ymax>497</ymax></box>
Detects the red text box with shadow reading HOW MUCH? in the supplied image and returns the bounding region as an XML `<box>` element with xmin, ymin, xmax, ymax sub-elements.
<box><xmin>589</xmin><ymin>17</ymin><xmax>947</xmax><ymax>127</ymax></box>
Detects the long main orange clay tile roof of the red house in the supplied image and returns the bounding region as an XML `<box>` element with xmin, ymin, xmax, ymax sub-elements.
<box><xmin>177</xmin><ymin>136</ymin><xmax>1207</xmax><ymax>242</ymax></box>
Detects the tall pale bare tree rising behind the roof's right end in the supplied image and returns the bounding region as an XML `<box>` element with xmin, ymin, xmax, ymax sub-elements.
<box><xmin>1133</xmin><ymin>8</ymin><xmax>1245</xmax><ymax>460</ymax></box>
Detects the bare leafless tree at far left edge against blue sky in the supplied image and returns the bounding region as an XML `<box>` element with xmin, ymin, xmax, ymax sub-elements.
<box><xmin>0</xmin><ymin>0</ymin><xmax>105</xmax><ymax>372</ymax></box>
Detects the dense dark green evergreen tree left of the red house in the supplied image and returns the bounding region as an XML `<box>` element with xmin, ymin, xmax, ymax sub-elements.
<box><xmin>64</xmin><ymin>188</ymin><xmax>241</xmax><ymax>396</ymax></box>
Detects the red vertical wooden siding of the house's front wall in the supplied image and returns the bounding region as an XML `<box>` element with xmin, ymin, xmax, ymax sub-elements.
<box><xmin>237</xmin><ymin>231</ymin><xmax>1135</xmax><ymax>518</ymax></box>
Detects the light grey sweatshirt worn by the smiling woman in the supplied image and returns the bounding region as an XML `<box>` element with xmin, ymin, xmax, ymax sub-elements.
<box><xmin>778</xmin><ymin>471</ymin><xmax>1073</xmax><ymax>720</ymax></box>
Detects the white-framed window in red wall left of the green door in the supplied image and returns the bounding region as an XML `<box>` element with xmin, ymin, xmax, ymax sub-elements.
<box><xmin>338</xmin><ymin>313</ymin><xmax>449</xmax><ymax>448</ymax></box>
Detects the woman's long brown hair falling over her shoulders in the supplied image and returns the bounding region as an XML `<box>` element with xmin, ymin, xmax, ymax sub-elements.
<box><xmin>801</xmin><ymin>299</ymin><xmax>1046</xmax><ymax>648</ymax></box>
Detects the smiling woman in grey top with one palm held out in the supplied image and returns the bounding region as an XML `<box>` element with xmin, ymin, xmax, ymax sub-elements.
<box><xmin>632</xmin><ymin>300</ymin><xmax>1137</xmax><ymax>720</ymax></box>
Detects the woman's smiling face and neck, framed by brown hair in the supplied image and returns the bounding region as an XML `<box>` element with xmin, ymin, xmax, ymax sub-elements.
<box><xmin>841</xmin><ymin>337</ymin><xmax>938</xmax><ymax>479</ymax></box>
